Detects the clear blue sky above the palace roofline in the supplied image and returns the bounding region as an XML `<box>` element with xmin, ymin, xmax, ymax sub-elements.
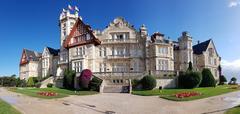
<box><xmin>0</xmin><ymin>0</ymin><xmax>240</xmax><ymax>76</ymax></box>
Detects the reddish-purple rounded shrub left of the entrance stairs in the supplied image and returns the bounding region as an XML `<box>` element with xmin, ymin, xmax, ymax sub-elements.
<box><xmin>79</xmin><ymin>69</ymin><xmax>92</xmax><ymax>89</ymax></box>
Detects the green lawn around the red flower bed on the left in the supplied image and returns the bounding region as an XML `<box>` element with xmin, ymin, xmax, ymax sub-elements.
<box><xmin>9</xmin><ymin>88</ymin><xmax>98</xmax><ymax>99</ymax></box>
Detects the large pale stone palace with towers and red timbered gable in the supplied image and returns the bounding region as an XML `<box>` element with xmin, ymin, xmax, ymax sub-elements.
<box><xmin>19</xmin><ymin>6</ymin><xmax>221</xmax><ymax>91</ymax></box>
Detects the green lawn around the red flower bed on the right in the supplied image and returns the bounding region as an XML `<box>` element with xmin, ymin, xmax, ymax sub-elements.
<box><xmin>132</xmin><ymin>85</ymin><xmax>240</xmax><ymax>101</ymax></box>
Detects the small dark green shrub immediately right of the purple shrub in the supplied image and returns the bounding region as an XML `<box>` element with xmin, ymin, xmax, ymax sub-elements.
<box><xmin>88</xmin><ymin>76</ymin><xmax>102</xmax><ymax>91</ymax></box>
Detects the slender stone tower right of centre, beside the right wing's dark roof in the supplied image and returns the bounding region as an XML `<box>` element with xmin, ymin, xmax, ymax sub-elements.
<box><xmin>178</xmin><ymin>31</ymin><xmax>193</xmax><ymax>71</ymax></box>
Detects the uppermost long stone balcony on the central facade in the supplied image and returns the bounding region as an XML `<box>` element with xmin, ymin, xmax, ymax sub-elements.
<box><xmin>102</xmin><ymin>39</ymin><xmax>138</xmax><ymax>44</ymax></box>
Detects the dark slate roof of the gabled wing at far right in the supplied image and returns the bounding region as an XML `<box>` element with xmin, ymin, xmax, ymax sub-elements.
<box><xmin>193</xmin><ymin>39</ymin><xmax>211</xmax><ymax>55</ymax></box>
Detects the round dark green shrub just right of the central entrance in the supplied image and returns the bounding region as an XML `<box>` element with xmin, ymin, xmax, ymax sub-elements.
<box><xmin>141</xmin><ymin>75</ymin><xmax>157</xmax><ymax>90</ymax></box>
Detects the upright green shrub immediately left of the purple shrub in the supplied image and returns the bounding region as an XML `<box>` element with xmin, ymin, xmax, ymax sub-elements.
<box><xmin>63</xmin><ymin>69</ymin><xmax>76</xmax><ymax>89</ymax></box>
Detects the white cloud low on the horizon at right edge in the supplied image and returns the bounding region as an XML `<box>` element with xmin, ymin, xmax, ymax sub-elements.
<box><xmin>221</xmin><ymin>59</ymin><xmax>240</xmax><ymax>82</ymax></box>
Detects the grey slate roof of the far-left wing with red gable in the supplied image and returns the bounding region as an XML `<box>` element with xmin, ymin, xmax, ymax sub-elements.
<box><xmin>24</xmin><ymin>49</ymin><xmax>42</xmax><ymax>61</ymax></box>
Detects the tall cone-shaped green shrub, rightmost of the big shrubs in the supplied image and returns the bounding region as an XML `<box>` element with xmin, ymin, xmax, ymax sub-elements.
<box><xmin>200</xmin><ymin>68</ymin><xmax>216</xmax><ymax>87</ymax></box>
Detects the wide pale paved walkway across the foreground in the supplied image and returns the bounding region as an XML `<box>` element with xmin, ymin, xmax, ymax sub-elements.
<box><xmin>0</xmin><ymin>88</ymin><xmax>240</xmax><ymax>114</ymax></box>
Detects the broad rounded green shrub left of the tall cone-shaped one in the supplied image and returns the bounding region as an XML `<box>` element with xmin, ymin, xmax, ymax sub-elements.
<box><xmin>178</xmin><ymin>71</ymin><xmax>202</xmax><ymax>89</ymax></box>
